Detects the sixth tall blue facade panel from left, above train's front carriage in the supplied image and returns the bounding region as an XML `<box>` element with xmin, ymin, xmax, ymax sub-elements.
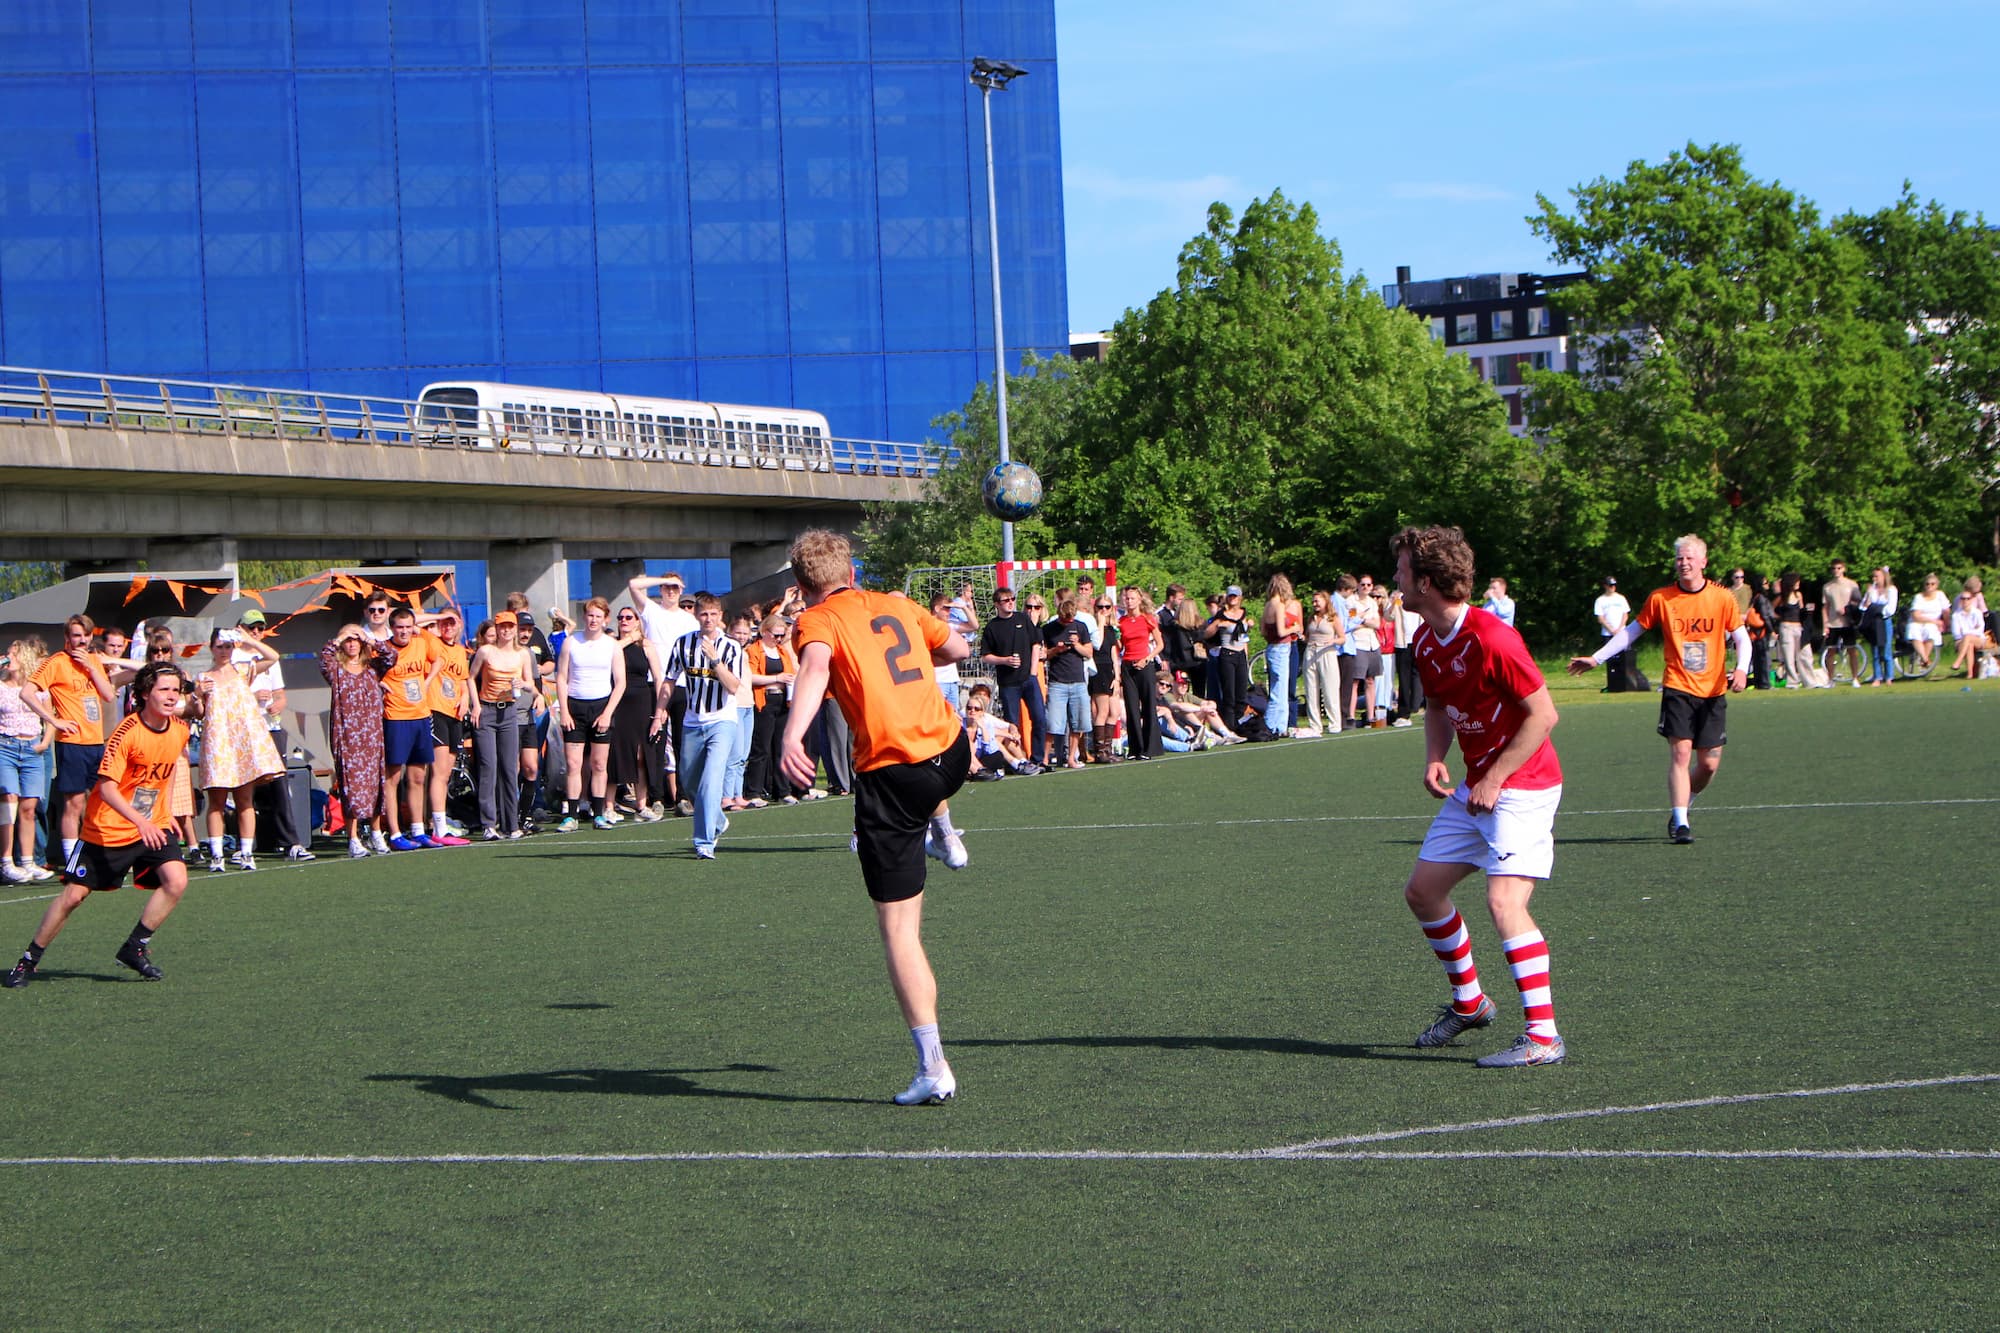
<box><xmin>494</xmin><ymin>70</ymin><xmax>598</xmax><ymax>362</ymax></box>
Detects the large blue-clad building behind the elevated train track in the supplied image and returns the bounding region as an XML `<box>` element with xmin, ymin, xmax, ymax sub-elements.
<box><xmin>0</xmin><ymin>0</ymin><xmax>1068</xmax><ymax>440</ymax></box>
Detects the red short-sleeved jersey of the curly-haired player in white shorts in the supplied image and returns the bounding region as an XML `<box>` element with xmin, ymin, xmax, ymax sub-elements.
<box><xmin>1410</xmin><ymin>606</ymin><xmax>1562</xmax><ymax>791</ymax></box>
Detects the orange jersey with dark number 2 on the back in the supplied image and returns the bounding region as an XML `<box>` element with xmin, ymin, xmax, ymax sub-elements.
<box><xmin>792</xmin><ymin>588</ymin><xmax>958</xmax><ymax>773</ymax></box>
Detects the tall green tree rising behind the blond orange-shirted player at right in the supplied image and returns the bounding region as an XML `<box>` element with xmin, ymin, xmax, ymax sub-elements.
<box><xmin>1528</xmin><ymin>144</ymin><xmax>1936</xmax><ymax>594</ymax></box>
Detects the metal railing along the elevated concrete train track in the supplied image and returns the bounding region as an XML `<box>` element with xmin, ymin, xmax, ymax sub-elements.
<box><xmin>0</xmin><ymin>366</ymin><xmax>946</xmax><ymax>476</ymax></box>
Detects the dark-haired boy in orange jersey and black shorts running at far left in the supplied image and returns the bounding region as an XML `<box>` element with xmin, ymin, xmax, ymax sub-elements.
<box><xmin>0</xmin><ymin>662</ymin><xmax>188</xmax><ymax>989</ymax></box>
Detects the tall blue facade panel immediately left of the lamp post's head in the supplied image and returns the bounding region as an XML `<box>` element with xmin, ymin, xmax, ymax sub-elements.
<box><xmin>874</xmin><ymin>64</ymin><xmax>976</xmax><ymax>352</ymax></box>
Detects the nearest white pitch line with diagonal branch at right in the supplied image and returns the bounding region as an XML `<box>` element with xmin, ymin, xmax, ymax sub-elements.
<box><xmin>0</xmin><ymin>1073</ymin><xmax>2000</xmax><ymax>1167</ymax></box>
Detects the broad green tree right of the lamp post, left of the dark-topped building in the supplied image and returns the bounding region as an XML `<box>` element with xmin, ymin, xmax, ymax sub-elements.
<box><xmin>1048</xmin><ymin>192</ymin><xmax>1528</xmax><ymax>582</ymax></box>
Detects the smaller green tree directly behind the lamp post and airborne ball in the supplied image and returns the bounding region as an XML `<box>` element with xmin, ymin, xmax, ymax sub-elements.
<box><xmin>856</xmin><ymin>352</ymin><xmax>1098</xmax><ymax>588</ymax></box>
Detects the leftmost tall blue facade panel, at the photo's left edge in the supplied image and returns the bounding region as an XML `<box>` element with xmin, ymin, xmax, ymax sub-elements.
<box><xmin>0</xmin><ymin>78</ymin><xmax>106</xmax><ymax>370</ymax></box>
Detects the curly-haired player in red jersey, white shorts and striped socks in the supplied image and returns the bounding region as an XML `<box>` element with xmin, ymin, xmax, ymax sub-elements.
<box><xmin>1390</xmin><ymin>528</ymin><xmax>1566</xmax><ymax>1069</ymax></box>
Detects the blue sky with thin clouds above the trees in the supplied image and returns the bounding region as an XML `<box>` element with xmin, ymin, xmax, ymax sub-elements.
<box><xmin>1056</xmin><ymin>0</ymin><xmax>2000</xmax><ymax>330</ymax></box>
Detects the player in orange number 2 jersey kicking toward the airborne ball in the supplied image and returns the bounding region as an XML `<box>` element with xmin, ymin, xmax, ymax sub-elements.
<box><xmin>780</xmin><ymin>528</ymin><xmax>972</xmax><ymax>1107</ymax></box>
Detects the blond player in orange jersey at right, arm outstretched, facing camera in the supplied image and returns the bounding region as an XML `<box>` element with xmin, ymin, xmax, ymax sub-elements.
<box><xmin>1570</xmin><ymin>534</ymin><xmax>1750</xmax><ymax>843</ymax></box>
